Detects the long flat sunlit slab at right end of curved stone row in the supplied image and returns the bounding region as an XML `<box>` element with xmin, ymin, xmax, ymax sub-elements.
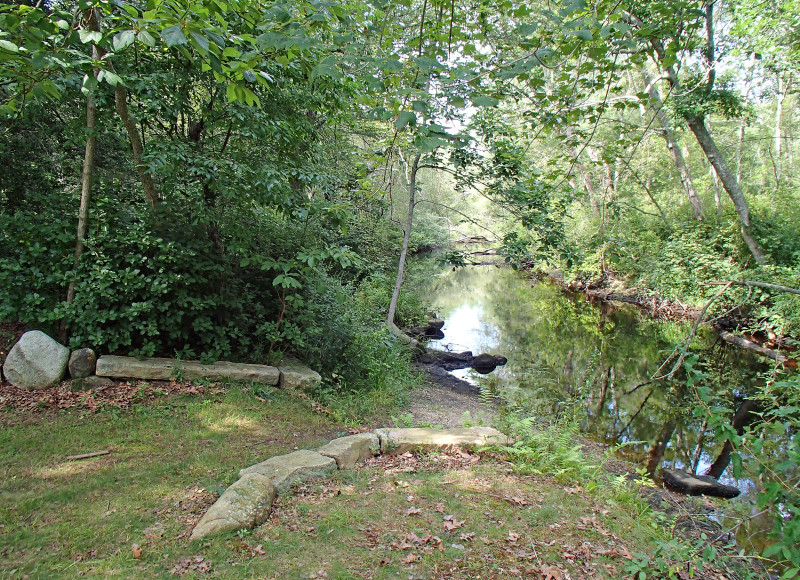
<box><xmin>375</xmin><ymin>427</ymin><xmax>509</xmax><ymax>454</ymax></box>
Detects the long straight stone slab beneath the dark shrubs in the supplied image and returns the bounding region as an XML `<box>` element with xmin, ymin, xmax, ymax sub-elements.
<box><xmin>95</xmin><ymin>356</ymin><xmax>280</xmax><ymax>385</ymax></box>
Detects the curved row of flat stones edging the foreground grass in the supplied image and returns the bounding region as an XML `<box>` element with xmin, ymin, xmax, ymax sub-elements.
<box><xmin>189</xmin><ymin>427</ymin><xmax>510</xmax><ymax>541</ymax></box>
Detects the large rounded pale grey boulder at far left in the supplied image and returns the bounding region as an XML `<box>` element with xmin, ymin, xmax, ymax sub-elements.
<box><xmin>3</xmin><ymin>330</ymin><xmax>69</xmax><ymax>390</ymax></box>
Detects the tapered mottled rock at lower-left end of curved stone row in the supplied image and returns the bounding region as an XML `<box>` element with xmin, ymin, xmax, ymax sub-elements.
<box><xmin>189</xmin><ymin>473</ymin><xmax>276</xmax><ymax>541</ymax></box>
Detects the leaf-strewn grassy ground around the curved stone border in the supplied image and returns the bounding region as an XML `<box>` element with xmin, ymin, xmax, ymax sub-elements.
<box><xmin>0</xmin><ymin>383</ymin><xmax>764</xmax><ymax>580</ymax></box>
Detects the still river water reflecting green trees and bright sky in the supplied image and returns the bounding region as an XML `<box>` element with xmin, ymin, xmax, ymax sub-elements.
<box><xmin>421</xmin><ymin>266</ymin><xmax>780</xmax><ymax>543</ymax></box>
